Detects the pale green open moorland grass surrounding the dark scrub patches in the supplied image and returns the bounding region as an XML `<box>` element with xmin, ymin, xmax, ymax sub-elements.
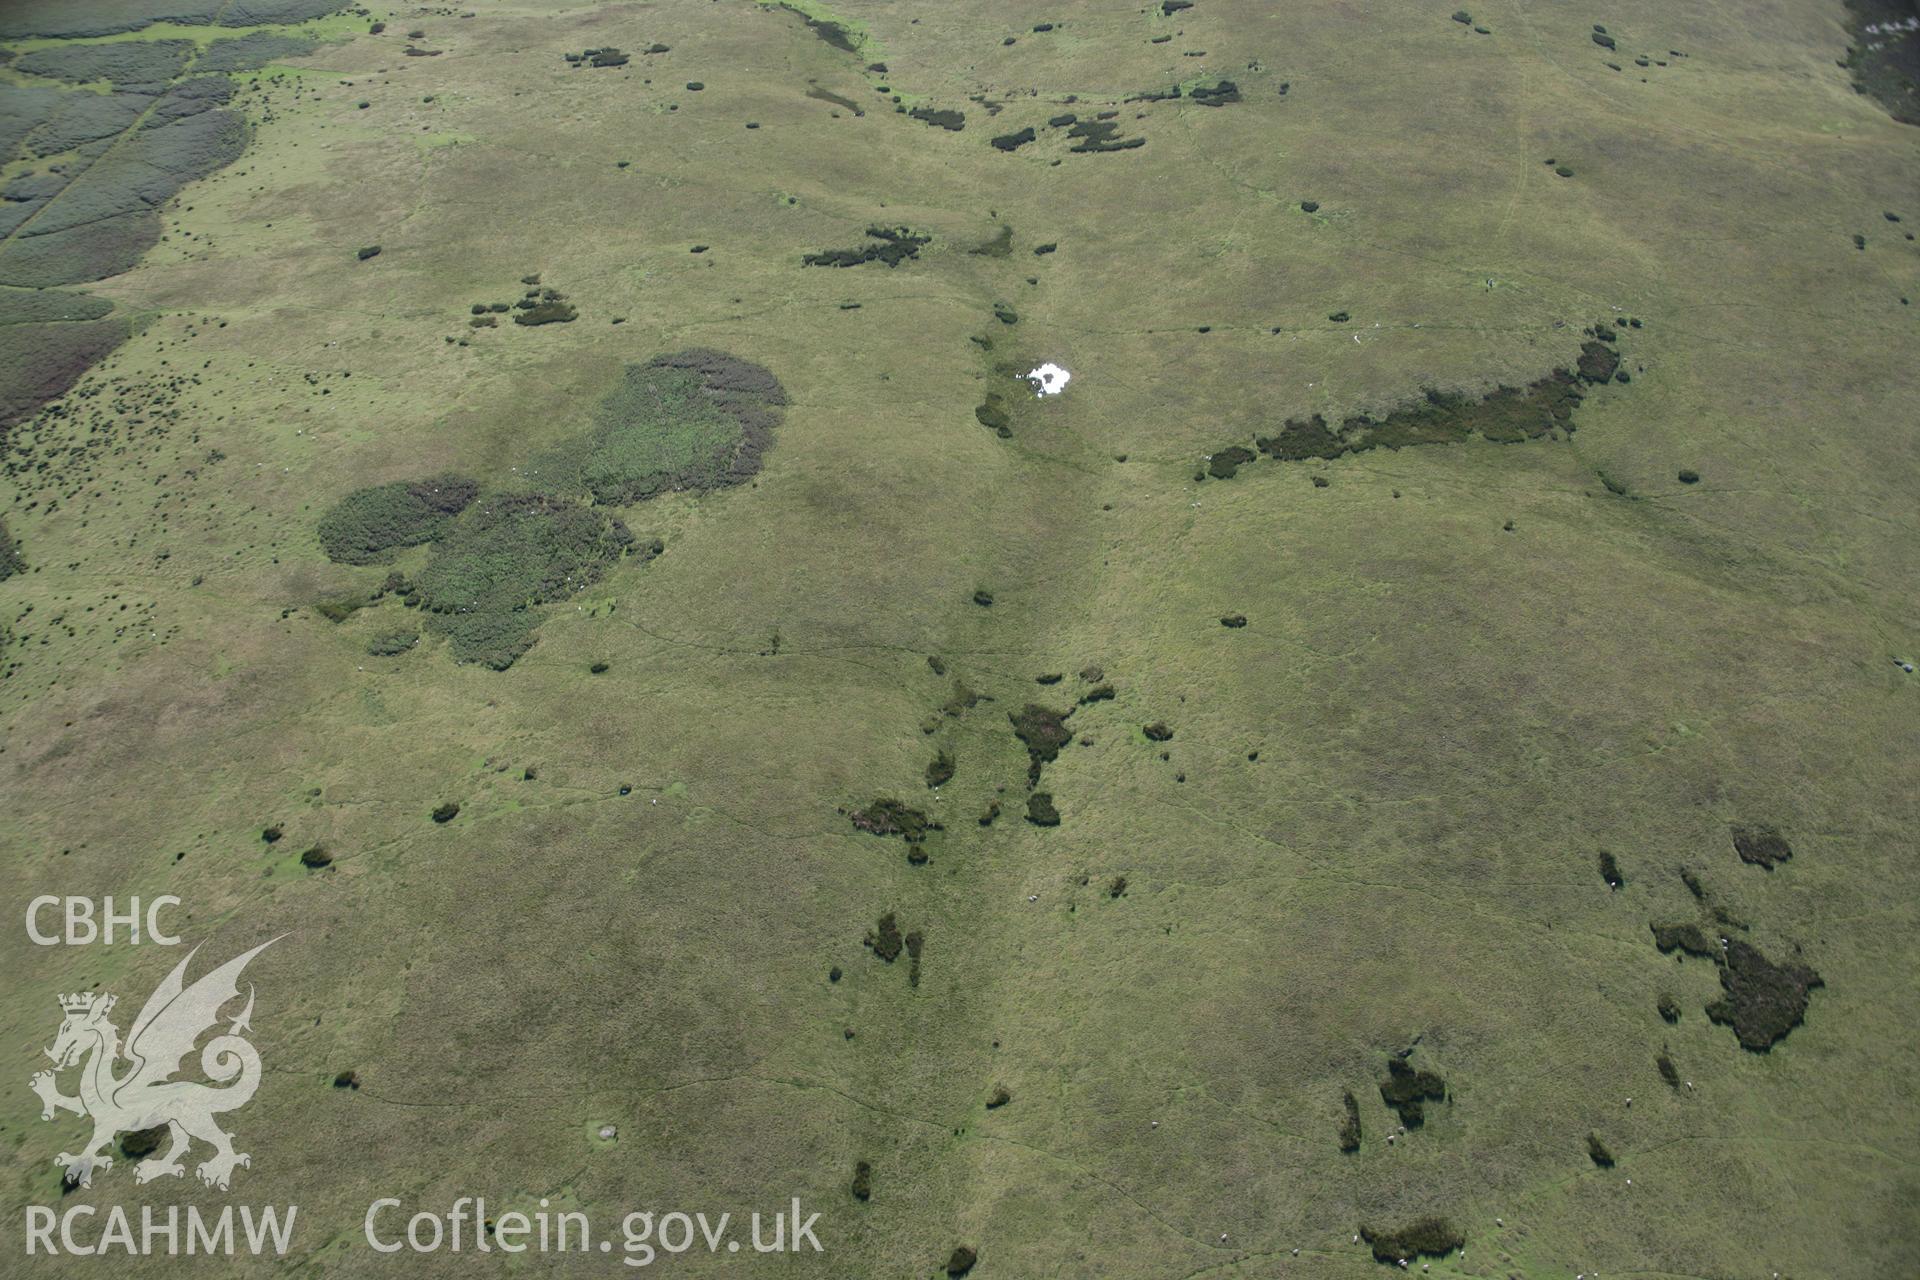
<box><xmin>0</xmin><ymin>0</ymin><xmax>1920</xmax><ymax>1278</ymax></box>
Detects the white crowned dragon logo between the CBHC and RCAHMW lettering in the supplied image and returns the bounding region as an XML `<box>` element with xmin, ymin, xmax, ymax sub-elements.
<box><xmin>29</xmin><ymin>938</ymin><xmax>278</xmax><ymax>1192</ymax></box>
